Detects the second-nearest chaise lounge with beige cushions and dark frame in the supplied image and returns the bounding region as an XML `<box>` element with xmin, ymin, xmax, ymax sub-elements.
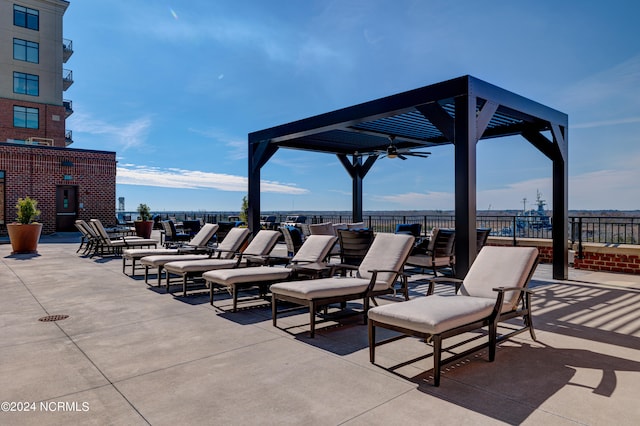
<box><xmin>271</xmin><ymin>233</ymin><xmax>414</xmax><ymax>337</ymax></box>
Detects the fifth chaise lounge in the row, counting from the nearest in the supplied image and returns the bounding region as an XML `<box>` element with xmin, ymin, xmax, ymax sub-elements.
<box><xmin>140</xmin><ymin>228</ymin><xmax>249</xmax><ymax>291</ymax></box>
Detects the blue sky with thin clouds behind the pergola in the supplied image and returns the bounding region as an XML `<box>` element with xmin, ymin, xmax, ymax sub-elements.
<box><xmin>64</xmin><ymin>0</ymin><xmax>640</xmax><ymax>211</ymax></box>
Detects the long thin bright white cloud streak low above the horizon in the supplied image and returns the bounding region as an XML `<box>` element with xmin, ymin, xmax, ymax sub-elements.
<box><xmin>116</xmin><ymin>164</ymin><xmax>309</xmax><ymax>195</ymax></box>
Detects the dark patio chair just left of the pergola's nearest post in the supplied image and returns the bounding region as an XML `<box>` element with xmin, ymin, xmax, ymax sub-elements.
<box><xmin>407</xmin><ymin>228</ymin><xmax>456</xmax><ymax>277</ymax></box>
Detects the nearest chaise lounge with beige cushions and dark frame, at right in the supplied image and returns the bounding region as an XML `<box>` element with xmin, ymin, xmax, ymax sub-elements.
<box><xmin>369</xmin><ymin>246</ymin><xmax>538</xmax><ymax>386</ymax></box>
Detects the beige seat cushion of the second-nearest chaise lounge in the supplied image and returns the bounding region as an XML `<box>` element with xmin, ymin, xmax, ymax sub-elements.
<box><xmin>271</xmin><ymin>277</ymin><xmax>370</xmax><ymax>300</ymax></box>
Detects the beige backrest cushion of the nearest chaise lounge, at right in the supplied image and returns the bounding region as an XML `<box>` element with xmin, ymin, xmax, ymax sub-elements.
<box><xmin>458</xmin><ymin>246</ymin><xmax>538</xmax><ymax>312</ymax></box>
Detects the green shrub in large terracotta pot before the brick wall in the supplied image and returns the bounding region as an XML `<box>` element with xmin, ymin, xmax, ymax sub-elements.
<box><xmin>7</xmin><ymin>197</ymin><xmax>42</xmax><ymax>254</ymax></box>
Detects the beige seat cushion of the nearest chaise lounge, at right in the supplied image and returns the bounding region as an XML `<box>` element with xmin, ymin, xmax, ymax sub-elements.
<box><xmin>369</xmin><ymin>292</ymin><xmax>496</xmax><ymax>334</ymax></box>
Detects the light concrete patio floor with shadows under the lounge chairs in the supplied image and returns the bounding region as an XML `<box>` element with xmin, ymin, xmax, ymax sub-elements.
<box><xmin>0</xmin><ymin>235</ymin><xmax>640</xmax><ymax>425</ymax></box>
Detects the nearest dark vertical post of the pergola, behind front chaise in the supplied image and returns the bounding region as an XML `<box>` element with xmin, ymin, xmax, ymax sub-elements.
<box><xmin>453</xmin><ymin>95</ymin><xmax>477</xmax><ymax>278</ymax></box>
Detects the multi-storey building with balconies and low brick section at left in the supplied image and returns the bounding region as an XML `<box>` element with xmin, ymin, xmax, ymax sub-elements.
<box><xmin>0</xmin><ymin>0</ymin><xmax>116</xmax><ymax>233</ymax></box>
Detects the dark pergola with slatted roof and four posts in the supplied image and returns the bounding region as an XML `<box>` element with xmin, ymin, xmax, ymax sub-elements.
<box><xmin>248</xmin><ymin>75</ymin><xmax>568</xmax><ymax>279</ymax></box>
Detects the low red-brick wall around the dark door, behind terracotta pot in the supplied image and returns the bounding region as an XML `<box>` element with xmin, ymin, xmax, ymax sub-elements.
<box><xmin>0</xmin><ymin>143</ymin><xmax>116</xmax><ymax>234</ymax></box>
